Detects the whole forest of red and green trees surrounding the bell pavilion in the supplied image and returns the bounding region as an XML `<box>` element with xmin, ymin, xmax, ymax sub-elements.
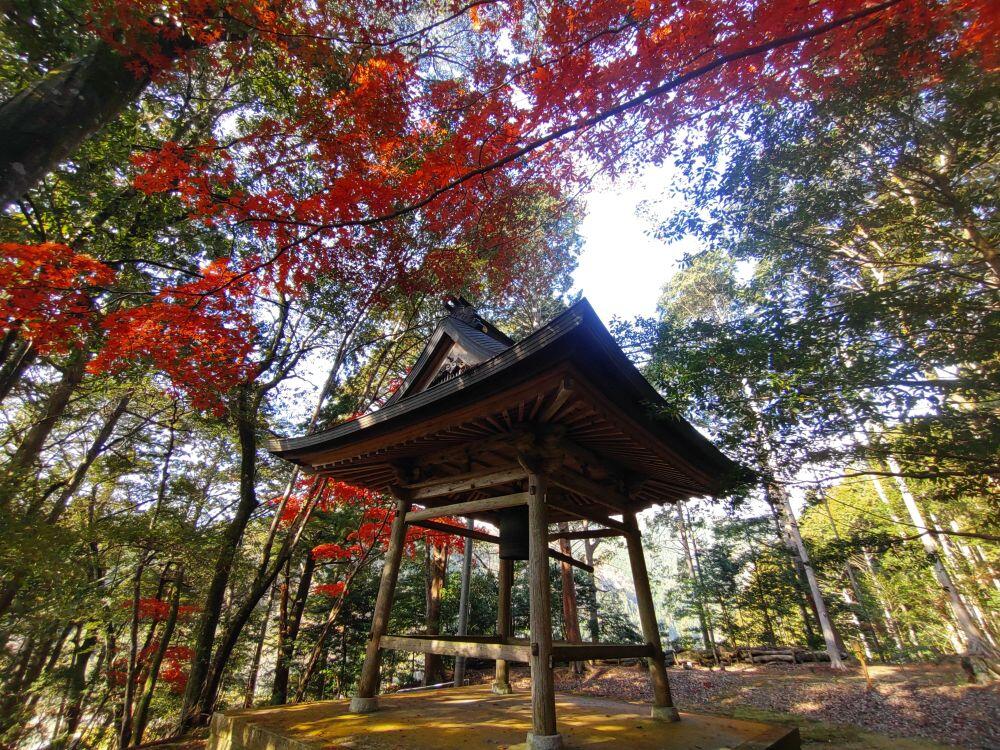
<box><xmin>0</xmin><ymin>0</ymin><xmax>1000</xmax><ymax>748</ymax></box>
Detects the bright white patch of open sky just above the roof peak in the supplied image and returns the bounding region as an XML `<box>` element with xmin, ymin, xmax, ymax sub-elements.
<box><xmin>574</xmin><ymin>167</ymin><xmax>697</xmax><ymax>323</ymax></box>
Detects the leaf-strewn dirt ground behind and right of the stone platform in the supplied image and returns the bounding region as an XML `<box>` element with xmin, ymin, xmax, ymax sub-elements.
<box><xmin>483</xmin><ymin>662</ymin><xmax>1000</xmax><ymax>750</ymax></box>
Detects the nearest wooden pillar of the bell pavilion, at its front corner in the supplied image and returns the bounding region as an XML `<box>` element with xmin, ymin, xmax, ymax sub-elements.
<box><xmin>528</xmin><ymin>473</ymin><xmax>562</xmax><ymax>750</ymax></box>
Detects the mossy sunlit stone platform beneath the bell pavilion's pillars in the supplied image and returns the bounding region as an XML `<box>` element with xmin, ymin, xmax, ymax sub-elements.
<box><xmin>207</xmin><ymin>685</ymin><xmax>800</xmax><ymax>750</ymax></box>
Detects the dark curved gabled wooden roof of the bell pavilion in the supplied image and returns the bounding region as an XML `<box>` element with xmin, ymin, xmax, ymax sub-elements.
<box><xmin>268</xmin><ymin>300</ymin><xmax>743</xmax><ymax>522</ymax></box>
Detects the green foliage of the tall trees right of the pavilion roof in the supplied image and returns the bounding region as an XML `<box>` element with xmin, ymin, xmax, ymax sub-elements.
<box><xmin>627</xmin><ymin>58</ymin><xmax>1000</xmax><ymax>658</ymax></box>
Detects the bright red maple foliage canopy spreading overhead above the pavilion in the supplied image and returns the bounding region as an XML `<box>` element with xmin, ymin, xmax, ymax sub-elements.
<box><xmin>0</xmin><ymin>0</ymin><xmax>1000</xmax><ymax>414</ymax></box>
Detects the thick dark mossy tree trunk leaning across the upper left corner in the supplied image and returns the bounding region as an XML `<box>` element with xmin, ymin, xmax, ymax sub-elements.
<box><xmin>0</xmin><ymin>42</ymin><xmax>149</xmax><ymax>209</ymax></box>
